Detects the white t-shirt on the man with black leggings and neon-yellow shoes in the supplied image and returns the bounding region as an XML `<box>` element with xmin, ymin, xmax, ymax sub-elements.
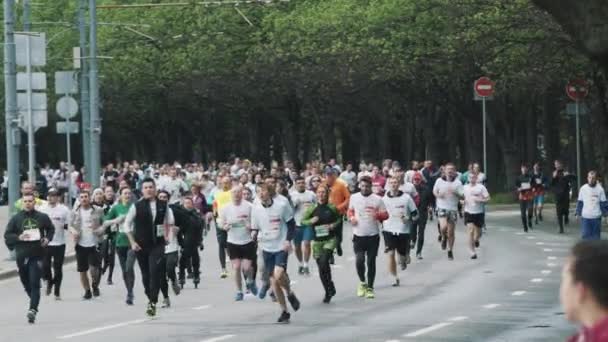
<box><xmin>348</xmin><ymin>192</ymin><xmax>385</xmax><ymax>236</ymax></box>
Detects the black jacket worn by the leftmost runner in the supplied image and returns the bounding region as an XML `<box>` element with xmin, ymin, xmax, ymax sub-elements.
<box><xmin>4</xmin><ymin>210</ymin><xmax>55</xmax><ymax>258</ymax></box>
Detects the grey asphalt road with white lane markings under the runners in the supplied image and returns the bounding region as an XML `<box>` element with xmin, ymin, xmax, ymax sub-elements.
<box><xmin>0</xmin><ymin>210</ymin><xmax>577</xmax><ymax>342</ymax></box>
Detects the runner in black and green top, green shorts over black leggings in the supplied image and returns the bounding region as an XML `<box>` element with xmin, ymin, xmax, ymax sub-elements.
<box><xmin>301</xmin><ymin>185</ymin><xmax>342</xmax><ymax>304</ymax></box>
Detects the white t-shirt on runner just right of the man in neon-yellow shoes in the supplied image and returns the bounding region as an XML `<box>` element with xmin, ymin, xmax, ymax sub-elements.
<box><xmin>382</xmin><ymin>193</ymin><xmax>417</xmax><ymax>234</ymax></box>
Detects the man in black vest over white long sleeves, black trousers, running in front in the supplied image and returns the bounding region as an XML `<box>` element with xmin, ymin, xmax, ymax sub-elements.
<box><xmin>125</xmin><ymin>178</ymin><xmax>175</xmax><ymax>317</ymax></box>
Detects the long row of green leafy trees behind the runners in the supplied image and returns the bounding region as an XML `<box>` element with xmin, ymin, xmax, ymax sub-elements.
<box><xmin>1</xmin><ymin>0</ymin><xmax>608</xmax><ymax>188</ymax></box>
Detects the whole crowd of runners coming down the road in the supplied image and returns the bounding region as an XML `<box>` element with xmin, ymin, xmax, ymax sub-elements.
<box><xmin>4</xmin><ymin>158</ymin><xmax>608</xmax><ymax>323</ymax></box>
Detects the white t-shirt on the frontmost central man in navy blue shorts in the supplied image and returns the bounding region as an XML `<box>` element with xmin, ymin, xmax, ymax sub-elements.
<box><xmin>251</xmin><ymin>198</ymin><xmax>293</xmax><ymax>252</ymax></box>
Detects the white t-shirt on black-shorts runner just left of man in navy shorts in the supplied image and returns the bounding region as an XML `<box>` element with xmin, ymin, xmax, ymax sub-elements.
<box><xmin>220</xmin><ymin>200</ymin><xmax>253</xmax><ymax>245</ymax></box>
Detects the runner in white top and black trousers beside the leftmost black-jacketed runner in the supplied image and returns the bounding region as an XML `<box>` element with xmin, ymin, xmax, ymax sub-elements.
<box><xmin>40</xmin><ymin>188</ymin><xmax>70</xmax><ymax>300</ymax></box>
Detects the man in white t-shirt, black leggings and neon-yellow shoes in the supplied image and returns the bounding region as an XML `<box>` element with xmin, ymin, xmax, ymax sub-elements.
<box><xmin>348</xmin><ymin>177</ymin><xmax>388</xmax><ymax>299</ymax></box>
